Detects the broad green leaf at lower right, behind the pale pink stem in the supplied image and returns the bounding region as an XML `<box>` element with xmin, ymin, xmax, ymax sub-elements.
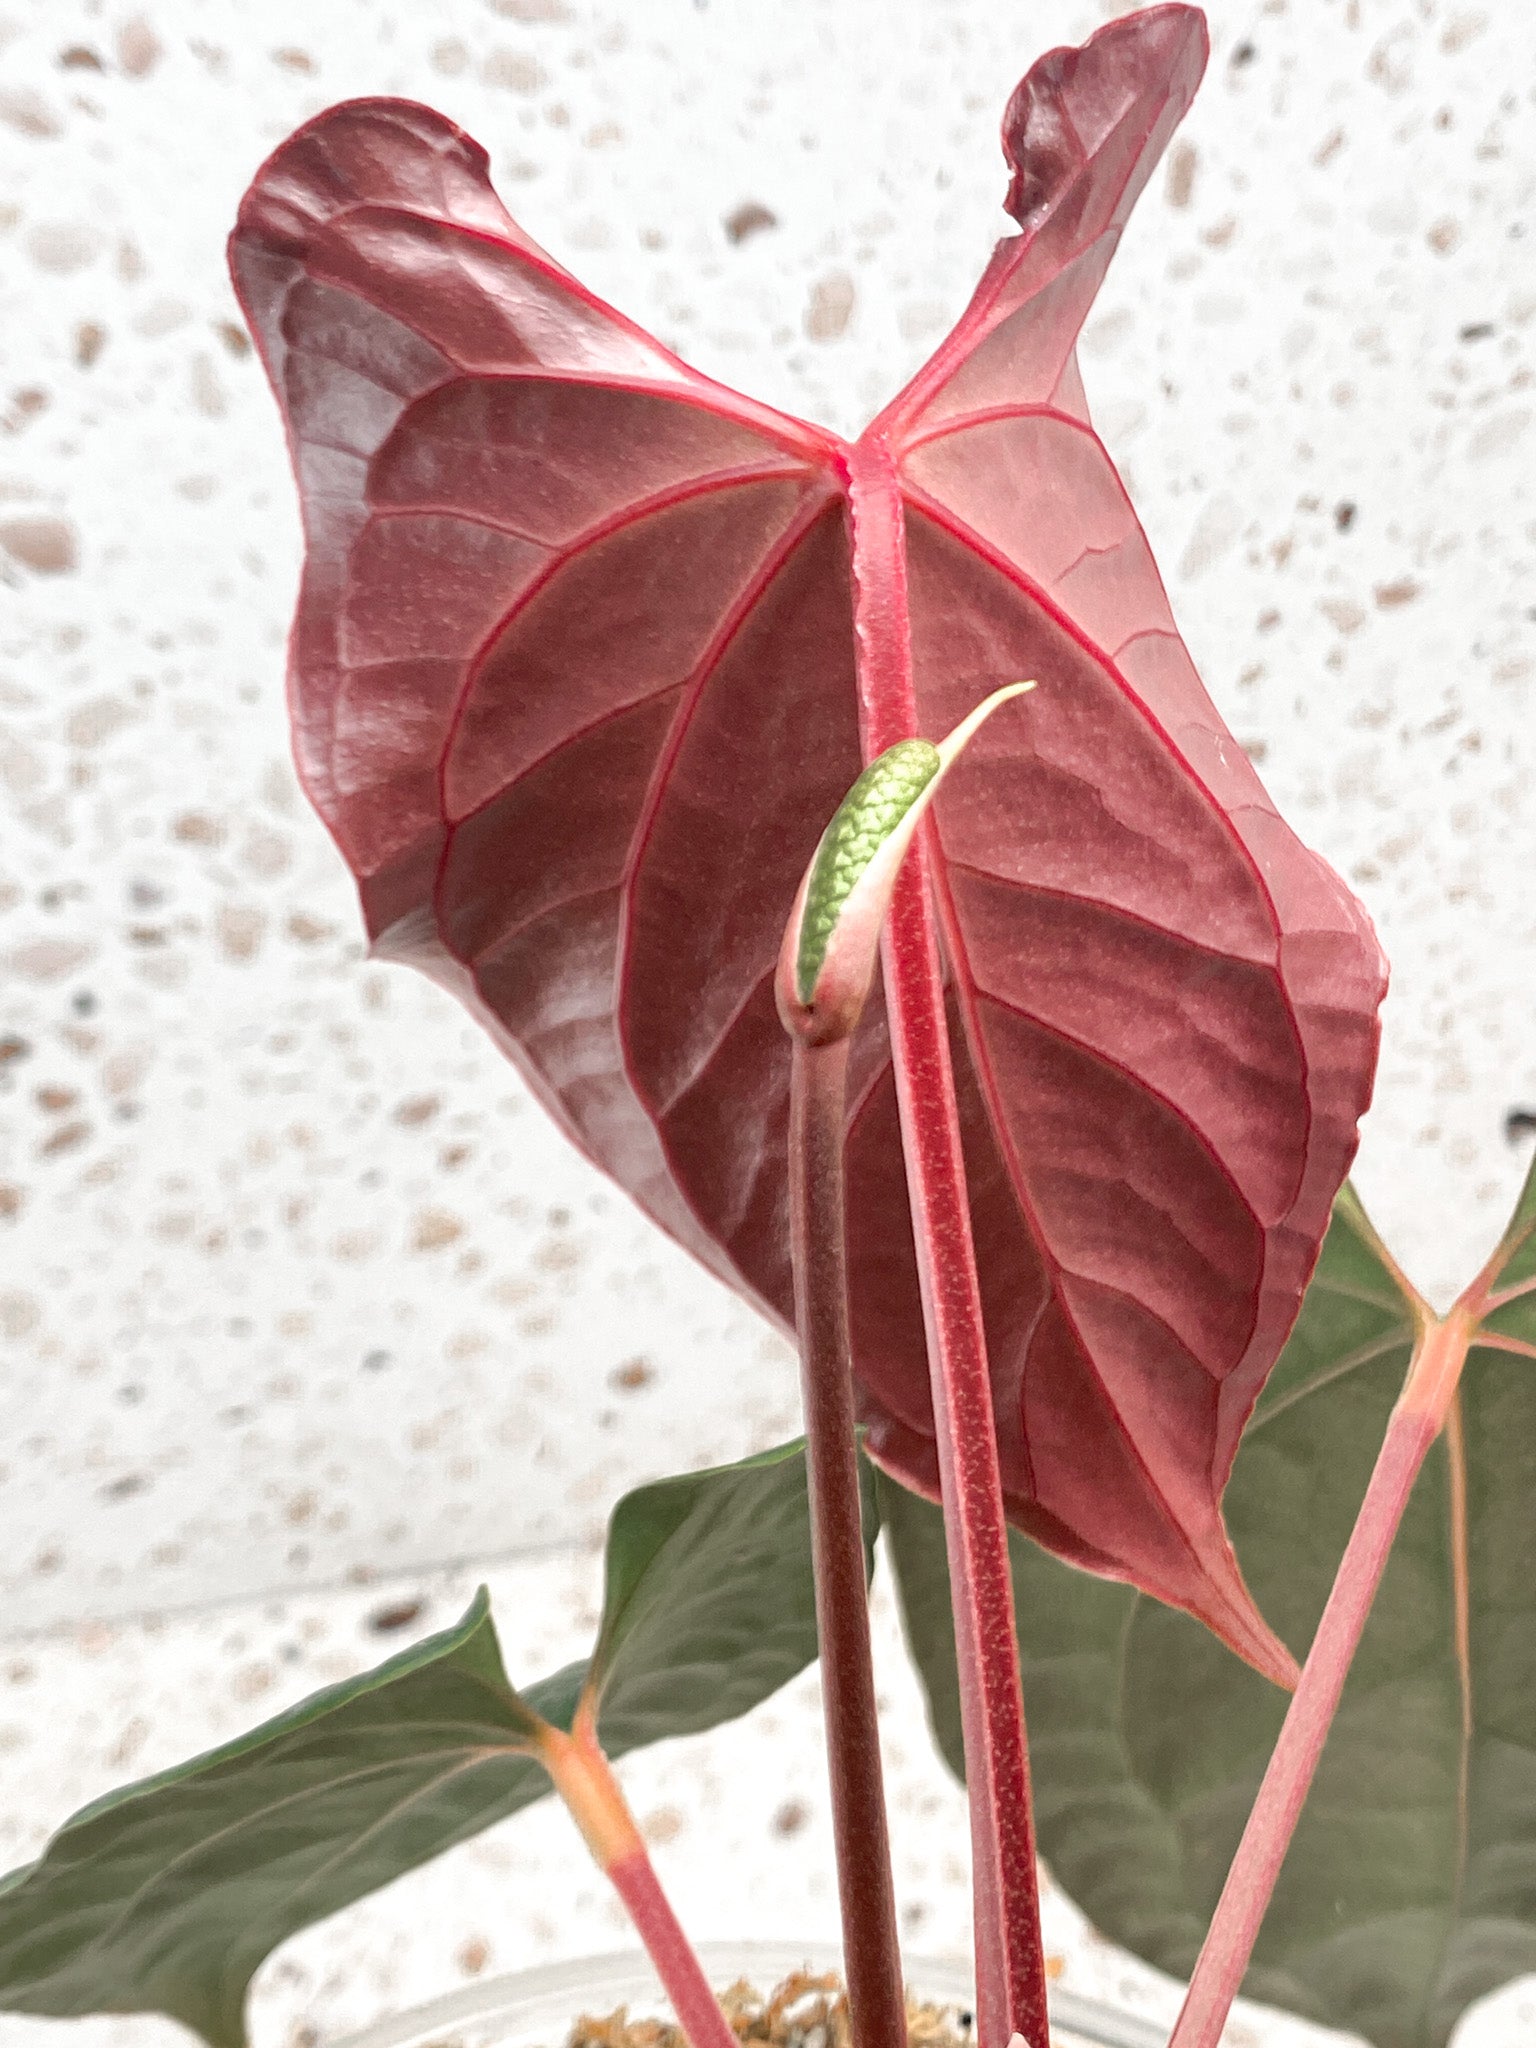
<box><xmin>881</xmin><ymin>1171</ymin><xmax>1536</xmax><ymax>2048</ymax></box>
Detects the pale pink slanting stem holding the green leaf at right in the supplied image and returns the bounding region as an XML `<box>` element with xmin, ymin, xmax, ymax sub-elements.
<box><xmin>1169</xmin><ymin>1290</ymin><xmax>1477</xmax><ymax>2048</ymax></box>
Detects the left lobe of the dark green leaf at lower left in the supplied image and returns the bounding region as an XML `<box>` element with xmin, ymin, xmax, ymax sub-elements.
<box><xmin>0</xmin><ymin>1591</ymin><xmax>557</xmax><ymax>2048</ymax></box>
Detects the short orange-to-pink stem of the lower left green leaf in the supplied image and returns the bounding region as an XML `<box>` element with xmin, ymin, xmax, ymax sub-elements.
<box><xmin>537</xmin><ymin>1712</ymin><xmax>739</xmax><ymax>2048</ymax></box>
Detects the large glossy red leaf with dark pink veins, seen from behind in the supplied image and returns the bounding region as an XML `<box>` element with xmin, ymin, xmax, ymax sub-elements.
<box><xmin>231</xmin><ymin>6</ymin><xmax>1384</xmax><ymax>1671</ymax></box>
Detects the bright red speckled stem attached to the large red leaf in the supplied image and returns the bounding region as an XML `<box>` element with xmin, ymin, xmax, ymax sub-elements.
<box><xmin>848</xmin><ymin>440</ymin><xmax>1049</xmax><ymax>2048</ymax></box>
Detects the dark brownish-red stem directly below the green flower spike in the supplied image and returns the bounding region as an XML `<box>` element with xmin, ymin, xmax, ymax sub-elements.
<box><xmin>788</xmin><ymin>1038</ymin><xmax>907</xmax><ymax>2048</ymax></box>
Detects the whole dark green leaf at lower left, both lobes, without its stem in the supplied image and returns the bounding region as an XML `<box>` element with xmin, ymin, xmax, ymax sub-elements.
<box><xmin>0</xmin><ymin>1444</ymin><xmax>843</xmax><ymax>2048</ymax></box>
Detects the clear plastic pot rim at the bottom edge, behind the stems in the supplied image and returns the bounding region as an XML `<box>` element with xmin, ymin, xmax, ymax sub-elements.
<box><xmin>328</xmin><ymin>1942</ymin><xmax>1167</xmax><ymax>2048</ymax></box>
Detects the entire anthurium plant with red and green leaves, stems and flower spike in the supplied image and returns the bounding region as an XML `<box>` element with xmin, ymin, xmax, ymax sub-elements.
<box><xmin>0</xmin><ymin>6</ymin><xmax>1536</xmax><ymax>2048</ymax></box>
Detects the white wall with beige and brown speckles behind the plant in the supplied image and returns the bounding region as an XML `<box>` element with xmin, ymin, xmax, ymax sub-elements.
<box><xmin>0</xmin><ymin>0</ymin><xmax>1536</xmax><ymax>1624</ymax></box>
